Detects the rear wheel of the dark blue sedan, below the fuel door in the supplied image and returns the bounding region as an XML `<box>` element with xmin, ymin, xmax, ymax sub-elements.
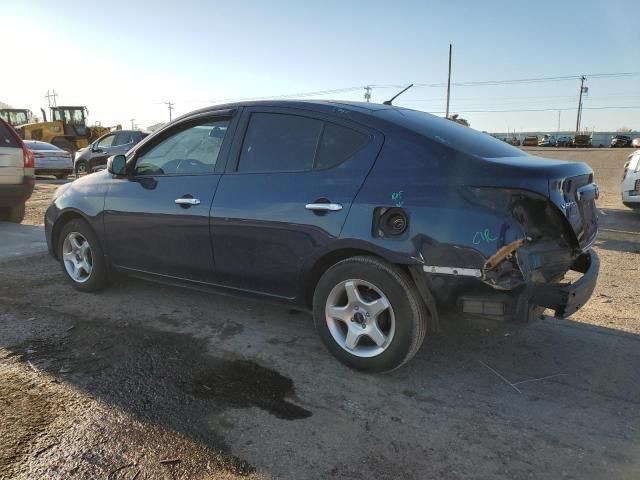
<box><xmin>313</xmin><ymin>256</ymin><xmax>428</xmax><ymax>372</ymax></box>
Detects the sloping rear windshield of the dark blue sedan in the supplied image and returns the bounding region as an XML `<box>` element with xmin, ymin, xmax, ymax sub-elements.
<box><xmin>376</xmin><ymin>108</ymin><xmax>527</xmax><ymax>158</ymax></box>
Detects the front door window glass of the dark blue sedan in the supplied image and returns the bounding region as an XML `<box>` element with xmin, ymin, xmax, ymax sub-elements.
<box><xmin>135</xmin><ymin>120</ymin><xmax>229</xmax><ymax>175</ymax></box>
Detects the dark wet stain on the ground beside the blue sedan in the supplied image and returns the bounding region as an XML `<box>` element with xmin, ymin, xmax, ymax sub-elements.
<box><xmin>10</xmin><ymin>323</ymin><xmax>312</xmax><ymax>420</ymax></box>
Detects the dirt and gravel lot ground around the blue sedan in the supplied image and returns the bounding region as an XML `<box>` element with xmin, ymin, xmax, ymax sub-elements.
<box><xmin>0</xmin><ymin>149</ymin><xmax>640</xmax><ymax>480</ymax></box>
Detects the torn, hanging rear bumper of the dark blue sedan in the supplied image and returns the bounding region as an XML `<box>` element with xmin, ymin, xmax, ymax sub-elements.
<box><xmin>529</xmin><ymin>250</ymin><xmax>600</xmax><ymax>318</ymax></box>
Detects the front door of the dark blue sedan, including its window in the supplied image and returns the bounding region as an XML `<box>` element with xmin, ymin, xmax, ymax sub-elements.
<box><xmin>104</xmin><ymin>110</ymin><xmax>234</xmax><ymax>282</ymax></box>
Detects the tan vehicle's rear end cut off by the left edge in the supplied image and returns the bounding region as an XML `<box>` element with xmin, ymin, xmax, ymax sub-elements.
<box><xmin>0</xmin><ymin>119</ymin><xmax>35</xmax><ymax>223</ymax></box>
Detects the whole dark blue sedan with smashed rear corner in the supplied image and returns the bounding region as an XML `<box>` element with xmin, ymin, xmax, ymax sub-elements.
<box><xmin>45</xmin><ymin>101</ymin><xmax>599</xmax><ymax>371</ymax></box>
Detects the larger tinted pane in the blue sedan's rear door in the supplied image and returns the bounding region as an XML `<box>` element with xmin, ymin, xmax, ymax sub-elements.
<box><xmin>238</xmin><ymin>113</ymin><xmax>323</xmax><ymax>172</ymax></box>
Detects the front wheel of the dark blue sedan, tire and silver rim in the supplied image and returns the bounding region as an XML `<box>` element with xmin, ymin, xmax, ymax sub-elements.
<box><xmin>58</xmin><ymin>218</ymin><xmax>107</xmax><ymax>292</ymax></box>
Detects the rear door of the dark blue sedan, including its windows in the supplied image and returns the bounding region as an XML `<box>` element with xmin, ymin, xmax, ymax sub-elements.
<box><xmin>211</xmin><ymin>108</ymin><xmax>382</xmax><ymax>298</ymax></box>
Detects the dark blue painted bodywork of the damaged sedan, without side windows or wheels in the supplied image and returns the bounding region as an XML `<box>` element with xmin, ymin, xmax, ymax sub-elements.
<box><xmin>46</xmin><ymin>101</ymin><xmax>597</xmax><ymax>322</ymax></box>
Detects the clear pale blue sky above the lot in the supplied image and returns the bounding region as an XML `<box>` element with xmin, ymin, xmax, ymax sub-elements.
<box><xmin>0</xmin><ymin>0</ymin><xmax>640</xmax><ymax>131</ymax></box>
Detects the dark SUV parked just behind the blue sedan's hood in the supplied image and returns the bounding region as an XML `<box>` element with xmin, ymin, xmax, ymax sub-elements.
<box><xmin>74</xmin><ymin>130</ymin><xmax>148</xmax><ymax>176</ymax></box>
